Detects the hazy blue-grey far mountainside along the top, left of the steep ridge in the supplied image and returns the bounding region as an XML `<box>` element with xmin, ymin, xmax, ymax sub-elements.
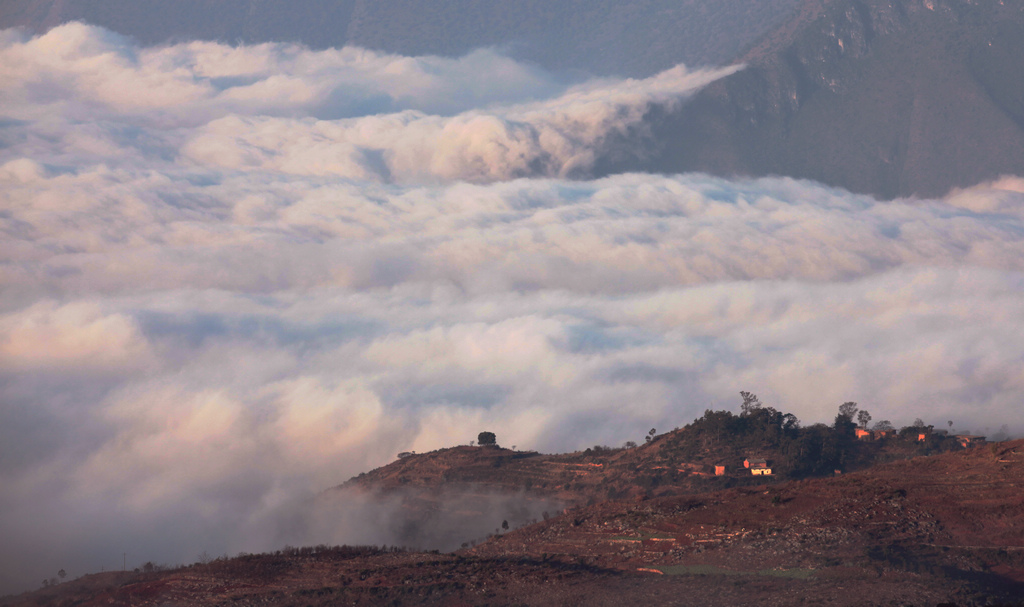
<box><xmin>0</xmin><ymin>0</ymin><xmax>799</xmax><ymax>76</ymax></box>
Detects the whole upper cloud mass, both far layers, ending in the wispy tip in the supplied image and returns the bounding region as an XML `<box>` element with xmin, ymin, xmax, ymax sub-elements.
<box><xmin>0</xmin><ymin>24</ymin><xmax>736</xmax><ymax>181</ymax></box>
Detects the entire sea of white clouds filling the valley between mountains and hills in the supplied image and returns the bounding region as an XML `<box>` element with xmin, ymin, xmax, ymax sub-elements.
<box><xmin>0</xmin><ymin>24</ymin><xmax>1024</xmax><ymax>591</ymax></box>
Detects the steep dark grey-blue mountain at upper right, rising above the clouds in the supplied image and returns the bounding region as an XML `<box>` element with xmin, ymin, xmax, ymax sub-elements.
<box><xmin>630</xmin><ymin>0</ymin><xmax>1024</xmax><ymax>198</ymax></box>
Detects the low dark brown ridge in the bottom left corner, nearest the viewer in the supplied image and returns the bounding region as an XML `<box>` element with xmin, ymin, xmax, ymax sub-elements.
<box><xmin>0</xmin><ymin>549</ymin><xmax>639</xmax><ymax>606</ymax></box>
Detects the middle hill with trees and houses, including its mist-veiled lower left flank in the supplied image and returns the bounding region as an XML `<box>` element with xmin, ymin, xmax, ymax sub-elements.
<box><xmin>327</xmin><ymin>407</ymin><xmax>962</xmax><ymax>550</ymax></box>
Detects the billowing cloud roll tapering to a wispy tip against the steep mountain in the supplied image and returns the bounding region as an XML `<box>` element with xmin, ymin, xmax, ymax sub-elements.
<box><xmin>182</xmin><ymin>67</ymin><xmax>735</xmax><ymax>182</ymax></box>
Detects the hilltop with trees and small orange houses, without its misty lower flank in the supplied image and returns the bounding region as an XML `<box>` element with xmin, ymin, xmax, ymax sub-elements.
<box><xmin>337</xmin><ymin>403</ymin><xmax>959</xmax><ymax>504</ymax></box>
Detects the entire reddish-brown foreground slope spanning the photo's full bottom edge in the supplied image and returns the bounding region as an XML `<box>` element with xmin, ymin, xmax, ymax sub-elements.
<box><xmin>8</xmin><ymin>440</ymin><xmax>1024</xmax><ymax>606</ymax></box>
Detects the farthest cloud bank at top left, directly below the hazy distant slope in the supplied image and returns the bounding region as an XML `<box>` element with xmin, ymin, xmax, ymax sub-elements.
<box><xmin>0</xmin><ymin>23</ymin><xmax>564</xmax><ymax>126</ymax></box>
